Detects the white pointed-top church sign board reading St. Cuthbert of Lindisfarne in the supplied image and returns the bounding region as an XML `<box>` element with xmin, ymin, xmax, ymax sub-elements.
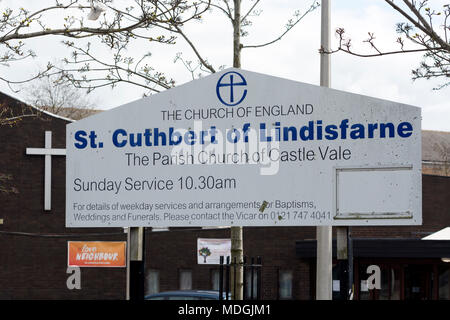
<box><xmin>66</xmin><ymin>69</ymin><xmax>422</xmax><ymax>227</ymax></box>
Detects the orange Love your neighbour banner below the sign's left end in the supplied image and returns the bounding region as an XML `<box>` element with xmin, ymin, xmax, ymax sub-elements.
<box><xmin>67</xmin><ymin>241</ymin><xmax>127</xmax><ymax>268</ymax></box>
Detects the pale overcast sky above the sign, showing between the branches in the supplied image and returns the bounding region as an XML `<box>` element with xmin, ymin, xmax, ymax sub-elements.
<box><xmin>0</xmin><ymin>0</ymin><xmax>450</xmax><ymax>132</ymax></box>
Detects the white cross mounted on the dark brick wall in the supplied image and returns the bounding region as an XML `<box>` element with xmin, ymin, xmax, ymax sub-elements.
<box><xmin>26</xmin><ymin>131</ymin><xmax>66</xmax><ymax>211</ymax></box>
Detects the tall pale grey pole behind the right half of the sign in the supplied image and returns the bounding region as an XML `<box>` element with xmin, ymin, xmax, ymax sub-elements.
<box><xmin>316</xmin><ymin>0</ymin><xmax>333</xmax><ymax>300</ymax></box>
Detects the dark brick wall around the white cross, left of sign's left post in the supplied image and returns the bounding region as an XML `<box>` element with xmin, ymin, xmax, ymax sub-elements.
<box><xmin>0</xmin><ymin>94</ymin><xmax>126</xmax><ymax>299</ymax></box>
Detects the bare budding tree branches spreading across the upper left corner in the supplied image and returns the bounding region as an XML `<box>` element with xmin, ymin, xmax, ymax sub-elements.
<box><xmin>0</xmin><ymin>0</ymin><xmax>210</xmax><ymax>92</ymax></box>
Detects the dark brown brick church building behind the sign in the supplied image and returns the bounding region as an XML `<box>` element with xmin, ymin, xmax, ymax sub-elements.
<box><xmin>0</xmin><ymin>94</ymin><xmax>450</xmax><ymax>300</ymax></box>
